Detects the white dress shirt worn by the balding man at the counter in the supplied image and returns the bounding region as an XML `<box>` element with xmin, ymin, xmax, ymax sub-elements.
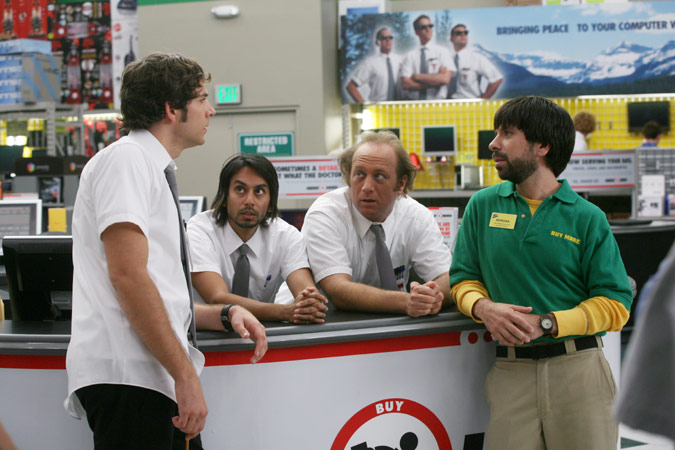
<box><xmin>302</xmin><ymin>187</ymin><xmax>452</xmax><ymax>289</ymax></box>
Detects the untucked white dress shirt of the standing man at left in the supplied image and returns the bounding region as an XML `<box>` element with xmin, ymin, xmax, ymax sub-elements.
<box><xmin>64</xmin><ymin>130</ymin><xmax>204</xmax><ymax>418</ymax></box>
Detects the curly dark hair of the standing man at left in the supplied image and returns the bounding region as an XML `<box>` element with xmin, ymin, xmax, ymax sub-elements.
<box><xmin>120</xmin><ymin>53</ymin><xmax>211</xmax><ymax>131</ymax></box>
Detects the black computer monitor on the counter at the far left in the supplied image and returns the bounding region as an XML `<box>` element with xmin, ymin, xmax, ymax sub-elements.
<box><xmin>2</xmin><ymin>236</ymin><xmax>73</xmax><ymax>321</ymax></box>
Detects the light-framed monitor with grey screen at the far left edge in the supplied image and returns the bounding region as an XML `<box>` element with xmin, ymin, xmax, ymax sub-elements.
<box><xmin>0</xmin><ymin>199</ymin><xmax>42</xmax><ymax>254</ymax></box>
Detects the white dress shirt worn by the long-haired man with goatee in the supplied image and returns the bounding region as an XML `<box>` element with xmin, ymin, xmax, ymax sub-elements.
<box><xmin>188</xmin><ymin>210</ymin><xmax>309</xmax><ymax>303</ymax></box>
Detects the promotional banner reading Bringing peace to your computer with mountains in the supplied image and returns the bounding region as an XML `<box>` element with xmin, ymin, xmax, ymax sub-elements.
<box><xmin>340</xmin><ymin>1</ymin><xmax>675</xmax><ymax>103</ymax></box>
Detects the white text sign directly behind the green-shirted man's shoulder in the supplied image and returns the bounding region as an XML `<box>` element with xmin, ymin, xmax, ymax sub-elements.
<box><xmin>559</xmin><ymin>150</ymin><xmax>635</xmax><ymax>189</ymax></box>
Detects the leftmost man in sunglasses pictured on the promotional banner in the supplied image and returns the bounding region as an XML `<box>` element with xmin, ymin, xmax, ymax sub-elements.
<box><xmin>347</xmin><ymin>28</ymin><xmax>401</xmax><ymax>103</ymax></box>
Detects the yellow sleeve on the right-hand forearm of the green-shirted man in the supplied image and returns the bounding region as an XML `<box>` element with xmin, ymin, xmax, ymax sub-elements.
<box><xmin>553</xmin><ymin>297</ymin><xmax>630</xmax><ymax>337</ymax></box>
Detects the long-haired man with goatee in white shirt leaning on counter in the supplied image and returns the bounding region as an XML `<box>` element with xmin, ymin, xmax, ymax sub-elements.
<box><xmin>188</xmin><ymin>154</ymin><xmax>328</xmax><ymax>323</ymax></box>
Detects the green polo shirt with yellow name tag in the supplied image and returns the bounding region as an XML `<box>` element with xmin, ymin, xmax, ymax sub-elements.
<box><xmin>450</xmin><ymin>180</ymin><xmax>632</xmax><ymax>340</ymax></box>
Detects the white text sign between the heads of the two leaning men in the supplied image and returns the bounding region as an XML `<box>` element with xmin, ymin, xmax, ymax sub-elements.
<box><xmin>269</xmin><ymin>156</ymin><xmax>345</xmax><ymax>198</ymax></box>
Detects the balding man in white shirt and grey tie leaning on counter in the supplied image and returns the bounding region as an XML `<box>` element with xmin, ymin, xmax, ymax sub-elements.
<box><xmin>302</xmin><ymin>131</ymin><xmax>452</xmax><ymax>317</ymax></box>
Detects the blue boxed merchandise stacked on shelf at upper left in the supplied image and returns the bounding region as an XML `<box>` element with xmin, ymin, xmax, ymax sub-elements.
<box><xmin>0</xmin><ymin>53</ymin><xmax>61</xmax><ymax>105</ymax></box>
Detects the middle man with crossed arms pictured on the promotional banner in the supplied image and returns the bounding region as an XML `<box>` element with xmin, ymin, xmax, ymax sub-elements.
<box><xmin>400</xmin><ymin>14</ymin><xmax>456</xmax><ymax>100</ymax></box>
